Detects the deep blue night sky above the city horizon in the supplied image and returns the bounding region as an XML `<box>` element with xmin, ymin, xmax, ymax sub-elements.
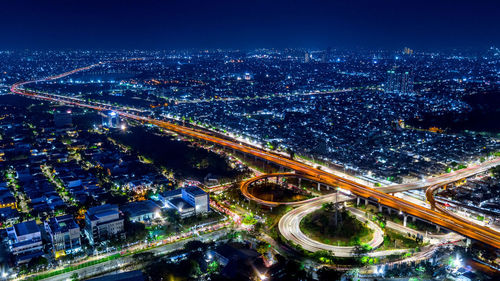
<box><xmin>0</xmin><ymin>0</ymin><xmax>500</xmax><ymax>50</ymax></box>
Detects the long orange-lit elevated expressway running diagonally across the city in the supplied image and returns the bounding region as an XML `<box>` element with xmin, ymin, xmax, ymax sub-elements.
<box><xmin>11</xmin><ymin>63</ymin><xmax>500</xmax><ymax>248</ymax></box>
